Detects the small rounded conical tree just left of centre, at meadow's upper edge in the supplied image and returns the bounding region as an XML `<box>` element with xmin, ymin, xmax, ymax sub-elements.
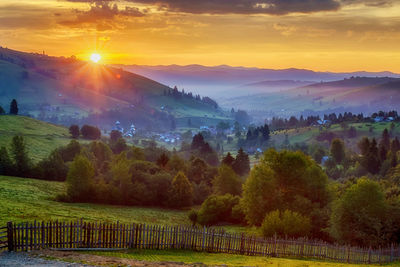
<box><xmin>169</xmin><ymin>172</ymin><xmax>193</xmax><ymax>208</ymax></box>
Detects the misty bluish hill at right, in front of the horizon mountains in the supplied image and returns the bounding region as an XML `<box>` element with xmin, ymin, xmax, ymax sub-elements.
<box><xmin>220</xmin><ymin>77</ymin><xmax>400</xmax><ymax>121</ymax></box>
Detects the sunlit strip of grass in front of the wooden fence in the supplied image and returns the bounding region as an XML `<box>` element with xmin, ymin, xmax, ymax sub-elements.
<box><xmin>85</xmin><ymin>250</ymin><xmax>398</xmax><ymax>267</ymax></box>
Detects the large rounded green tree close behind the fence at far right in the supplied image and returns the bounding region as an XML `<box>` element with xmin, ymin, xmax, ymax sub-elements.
<box><xmin>329</xmin><ymin>178</ymin><xmax>387</xmax><ymax>246</ymax></box>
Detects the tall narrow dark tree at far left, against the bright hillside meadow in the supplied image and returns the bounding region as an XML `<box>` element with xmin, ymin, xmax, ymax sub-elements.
<box><xmin>11</xmin><ymin>135</ymin><xmax>31</xmax><ymax>177</ymax></box>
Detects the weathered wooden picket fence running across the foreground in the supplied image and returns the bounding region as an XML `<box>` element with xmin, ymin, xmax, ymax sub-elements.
<box><xmin>0</xmin><ymin>221</ymin><xmax>400</xmax><ymax>264</ymax></box>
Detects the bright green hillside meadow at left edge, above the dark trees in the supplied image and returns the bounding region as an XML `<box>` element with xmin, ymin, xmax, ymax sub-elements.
<box><xmin>0</xmin><ymin>115</ymin><xmax>75</xmax><ymax>162</ymax></box>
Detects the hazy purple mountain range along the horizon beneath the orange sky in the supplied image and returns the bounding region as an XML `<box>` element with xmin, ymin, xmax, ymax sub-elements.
<box><xmin>113</xmin><ymin>65</ymin><xmax>400</xmax><ymax>98</ymax></box>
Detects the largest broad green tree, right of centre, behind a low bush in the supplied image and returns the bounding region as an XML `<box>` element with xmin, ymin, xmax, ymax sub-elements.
<box><xmin>241</xmin><ymin>149</ymin><xmax>330</xmax><ymax>238</ymax></box>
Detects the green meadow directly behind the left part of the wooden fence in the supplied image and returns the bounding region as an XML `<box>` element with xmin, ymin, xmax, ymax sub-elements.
<box><xmin>0</xmin><ymin>176</ymin><xmax>189</xmax><ymax>225</ymax></box>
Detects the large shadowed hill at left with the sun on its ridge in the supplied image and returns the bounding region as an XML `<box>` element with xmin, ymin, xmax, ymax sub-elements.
<box><xmin>0</xmin><ymin>48</ymin><xmax>224</xmax><ymax>130</ymax></box>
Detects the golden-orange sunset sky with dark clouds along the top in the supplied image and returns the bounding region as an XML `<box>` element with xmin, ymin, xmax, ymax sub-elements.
<box><xmin>0</xmin><ymin>0</ymin><xmax>400</xmax><ymax>72</ymax></box>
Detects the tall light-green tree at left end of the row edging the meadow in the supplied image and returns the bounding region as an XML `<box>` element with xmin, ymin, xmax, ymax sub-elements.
<box><xmin>67</xmin><ymin>155</ymin><xmax>95</xmax><ymax>202</ymax></box>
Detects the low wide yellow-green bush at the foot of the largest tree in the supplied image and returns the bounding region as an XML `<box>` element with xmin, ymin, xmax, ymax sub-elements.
<box><xmin>261</xmin><ymin>210</ymin><xmax>311</xmax><ymax>238</ymax></box>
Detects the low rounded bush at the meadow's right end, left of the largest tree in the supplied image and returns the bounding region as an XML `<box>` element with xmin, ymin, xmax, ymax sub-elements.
<box><xmin>197</xmin><ymin>194</ymin><xmax>239</xmax><ymax>225</ymax></box>
